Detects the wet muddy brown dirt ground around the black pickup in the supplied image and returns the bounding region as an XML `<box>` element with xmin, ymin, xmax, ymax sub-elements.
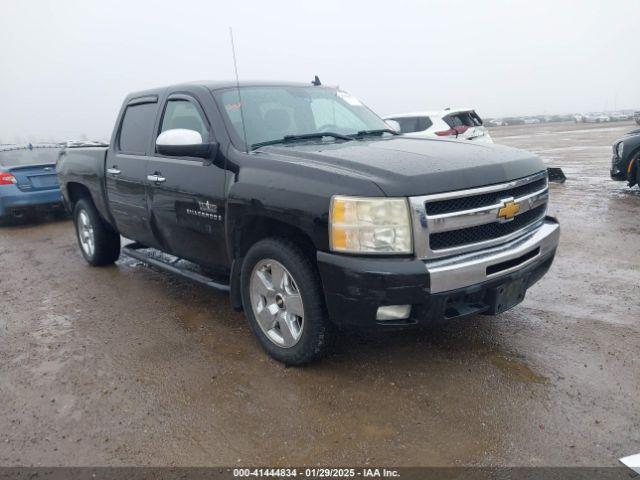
<box><xmin>0</xmin><ymin>122</ymin><xmax>640</xmax><ymax>466</ymax></box>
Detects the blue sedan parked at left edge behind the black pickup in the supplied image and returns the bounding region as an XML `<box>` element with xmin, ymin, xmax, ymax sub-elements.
<box><xmin>0</xmin><ymin>144</ymin><xmax>63</xmax><ymax>221</ymax></box>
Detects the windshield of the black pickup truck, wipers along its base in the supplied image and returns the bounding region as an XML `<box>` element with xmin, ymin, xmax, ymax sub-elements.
<box><xmin>214</xmin><ymin>86</ymin><xmax>389</xmax><ymax>146</ymax></box>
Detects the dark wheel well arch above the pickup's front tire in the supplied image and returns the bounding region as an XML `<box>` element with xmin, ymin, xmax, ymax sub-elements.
<box><xmin>233</xmin><ymin>215</ymin><xmax>316</xmax><ymax>263</ymax></box>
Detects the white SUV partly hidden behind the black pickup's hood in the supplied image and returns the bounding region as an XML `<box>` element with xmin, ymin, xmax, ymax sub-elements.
<box><xmin>384</xmin><ymin>108</ymin><xmax>493</xmax><ymax>143</ymax></box>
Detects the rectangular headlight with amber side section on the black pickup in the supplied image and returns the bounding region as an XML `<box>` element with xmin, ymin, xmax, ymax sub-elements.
<box><xmin>329</xmin><ymin>195</ymin><xmax>413</xmax><ymax>254</ymax></box>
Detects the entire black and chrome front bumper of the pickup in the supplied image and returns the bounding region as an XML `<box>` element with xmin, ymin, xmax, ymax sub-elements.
<box><xmin>318</xmin><ymin>217</ymin><xmax>560</xmax><ymax>328</ymax></box>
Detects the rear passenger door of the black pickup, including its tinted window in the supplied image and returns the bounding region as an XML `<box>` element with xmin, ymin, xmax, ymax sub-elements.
<box><xmin>105</xmin><ymin>96</ymin><xmax>158</xmax><ymax>246</ymax></box>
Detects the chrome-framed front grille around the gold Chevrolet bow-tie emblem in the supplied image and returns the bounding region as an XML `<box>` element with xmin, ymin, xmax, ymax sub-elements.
<box><xmin>410</xmin><ymin>171</ymin><xmax>549</xmax><ymax>258</ymax></box>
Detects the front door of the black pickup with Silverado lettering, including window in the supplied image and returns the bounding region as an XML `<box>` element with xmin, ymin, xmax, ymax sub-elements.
<box><xmin>147</xmin><ymin>94</ymin><xmax>228</xmax><ymax>267</ymax></box>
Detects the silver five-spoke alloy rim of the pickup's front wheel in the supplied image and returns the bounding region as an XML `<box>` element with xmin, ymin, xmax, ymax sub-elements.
<box><xmin>249</xmin><ymin>259</ymin><xmax>304</xmax><ymax>348</ymax></box>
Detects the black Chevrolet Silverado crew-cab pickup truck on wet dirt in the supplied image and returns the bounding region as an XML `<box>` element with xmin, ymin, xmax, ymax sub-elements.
<box><xmin>57</xmin><ymin>82</ymin><xmax>559</xmax><ymax>364</ymax></box>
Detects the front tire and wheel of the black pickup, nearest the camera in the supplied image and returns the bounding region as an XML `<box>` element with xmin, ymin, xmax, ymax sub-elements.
<box><xmin>240</xmin><ymin>238</ymin><xmax>335</xmax><ymax>365</ymax></box>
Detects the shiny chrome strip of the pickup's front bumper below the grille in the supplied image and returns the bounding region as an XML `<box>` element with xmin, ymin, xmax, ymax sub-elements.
<box><xmin>425</xmin><ymin>217</ymin><xmax>560</xmax><ymax>293</ymax></box>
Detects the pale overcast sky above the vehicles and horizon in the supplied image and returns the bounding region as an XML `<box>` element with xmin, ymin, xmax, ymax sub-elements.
<box><xmin>0</xmin><ymin>0</ymin><xmax>640</xmax><ymax>142</ymax></box>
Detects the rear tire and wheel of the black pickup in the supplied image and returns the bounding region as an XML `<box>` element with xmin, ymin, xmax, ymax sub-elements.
<box><xmin>73</xmin><ymin>198</ymin><xmax>120</xmax><ymax>267</ymax></box>
